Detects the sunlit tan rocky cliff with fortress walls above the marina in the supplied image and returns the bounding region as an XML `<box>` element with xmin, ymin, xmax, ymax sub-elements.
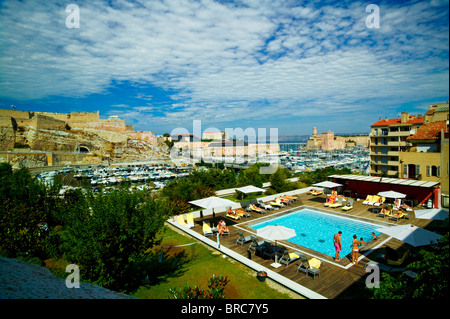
<box><xmin>0</xmin><ymin>109</ymin><xmax>169</xmax><ymax>166</ymax></box>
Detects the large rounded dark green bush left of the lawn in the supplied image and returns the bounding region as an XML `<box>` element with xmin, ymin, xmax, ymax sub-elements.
<box><xmin>62</xmin><ymin>189</ymin><xmax>171</xmax><ymax>290</ymax></box>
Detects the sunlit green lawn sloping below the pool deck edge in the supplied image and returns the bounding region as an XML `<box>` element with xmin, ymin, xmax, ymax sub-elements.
<box><xmin>132</xmin><ymin>226</ymin><xmax>299</xmax><ymax>299</ymax></box>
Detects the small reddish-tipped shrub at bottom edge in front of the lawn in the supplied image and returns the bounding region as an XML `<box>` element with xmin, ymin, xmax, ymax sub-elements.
<box><xmin>169</xmin><ymin>275</ymin><xmax>229</xmax><ymax>299</ymax></box>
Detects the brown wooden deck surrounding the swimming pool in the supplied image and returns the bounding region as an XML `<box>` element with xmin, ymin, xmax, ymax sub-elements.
<box><xmin>173</xmin><ymin>194</ymin><xmax>436</xmax><ymax>299</ymax></box>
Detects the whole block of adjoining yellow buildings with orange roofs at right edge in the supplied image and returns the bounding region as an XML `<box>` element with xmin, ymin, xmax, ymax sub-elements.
<box><xmin>370</xmin><ymin>102</ymin><xmax>449</xmax><ymax>207</ymax></box>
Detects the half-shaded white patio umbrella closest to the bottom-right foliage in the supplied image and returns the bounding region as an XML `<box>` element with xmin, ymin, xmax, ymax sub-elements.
<box><xmin>377</xmin><ymin>224</ymin><xmax>441</xmax><ymax>247</ymax></box>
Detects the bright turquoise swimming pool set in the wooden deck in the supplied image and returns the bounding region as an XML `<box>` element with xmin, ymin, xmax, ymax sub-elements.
<box><xmin>250</xmin><ymin>208</ymin><xmax>380</xmax><ymax>258</ymax></box>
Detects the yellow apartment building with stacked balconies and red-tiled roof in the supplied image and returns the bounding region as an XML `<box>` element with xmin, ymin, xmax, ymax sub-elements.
<box><xmin>369</xmin><ymin>112</ymin><xmax>424</xmax><ymax>178</ymax></box>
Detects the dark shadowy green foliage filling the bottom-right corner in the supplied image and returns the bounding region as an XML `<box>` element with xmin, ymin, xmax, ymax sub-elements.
<box><xmin>372</xmin><ymin>233</ymin><xmax>449</xmax><ymax>299</ymax></box>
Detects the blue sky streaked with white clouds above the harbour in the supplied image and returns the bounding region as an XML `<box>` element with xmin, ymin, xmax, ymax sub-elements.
<box><xmin>0</xmin><ymin>0</ymin><xmax>449</xmax><ymax>135</ymax></box>
